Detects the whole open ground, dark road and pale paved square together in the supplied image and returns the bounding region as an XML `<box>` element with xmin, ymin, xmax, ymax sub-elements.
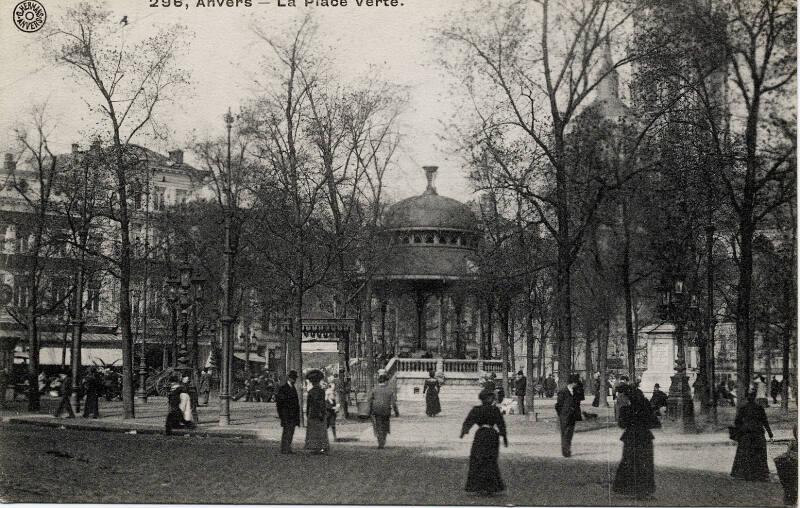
<box><xmin>0</xmin><ymin>392</ymin><xmax>796</xmax><ymax>506</ymax></box>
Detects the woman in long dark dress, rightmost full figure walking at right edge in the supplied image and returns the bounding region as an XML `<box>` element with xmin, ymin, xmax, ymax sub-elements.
<box><xmin>731</xmin><ymin>391</ymin><xmax>772</xmax><ymax>482</ymax></box>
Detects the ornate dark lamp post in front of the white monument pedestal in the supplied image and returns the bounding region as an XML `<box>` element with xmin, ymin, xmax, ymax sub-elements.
<box><xmin>659</xmin><ymin>276</ymin><xmax>697</xmax><ymax>431</ymax></box>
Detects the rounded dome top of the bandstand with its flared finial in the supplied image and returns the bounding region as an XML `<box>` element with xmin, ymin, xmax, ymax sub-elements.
<box><xmin>384</xmin><ymin>166</ymin><xmax>478</xmax><ymax>231</ymax></box>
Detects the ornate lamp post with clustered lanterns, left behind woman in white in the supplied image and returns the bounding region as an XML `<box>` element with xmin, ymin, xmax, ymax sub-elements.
<box><xmin>167</xmin><ymin>260</ymin><xmax>205</xmax><ymax>424</ymax></box>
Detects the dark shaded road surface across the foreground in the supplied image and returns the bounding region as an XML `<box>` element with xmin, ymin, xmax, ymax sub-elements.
<box><xmin>0</xmin><ymin>425</ymin><xmax>782</xmax><ymax>506</ymax></box>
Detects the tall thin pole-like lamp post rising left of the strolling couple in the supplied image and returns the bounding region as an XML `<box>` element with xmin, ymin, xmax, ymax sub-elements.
<box><xmin>219</xmin><ymin>108</ymin><xmax>233</xmax><ymax>425</ymax></box>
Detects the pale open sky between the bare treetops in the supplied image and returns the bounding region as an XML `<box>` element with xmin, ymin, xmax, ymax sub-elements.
<box><xmin>0</xmin><ymin>0</ymin><xmax>473</xmax><ymax>200</ymax></box>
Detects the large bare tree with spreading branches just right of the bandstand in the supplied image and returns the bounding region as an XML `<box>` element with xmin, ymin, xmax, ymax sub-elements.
<box><xmin>440</xmin><ymin>0</ymin><xmax>672</xmax><ymax>383</ymax></box>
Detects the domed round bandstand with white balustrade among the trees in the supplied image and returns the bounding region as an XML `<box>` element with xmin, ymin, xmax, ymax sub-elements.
<box><xmin>351</xmin><ymin>166</ymin><xmax>501</xmax><ymax>400</ymax></box>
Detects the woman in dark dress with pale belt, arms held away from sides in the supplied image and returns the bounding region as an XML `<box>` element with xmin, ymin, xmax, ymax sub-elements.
<box><xmin>461</xmin><ymin>390</ymin><xmax>508</xmax><ymax>495</ymax></box>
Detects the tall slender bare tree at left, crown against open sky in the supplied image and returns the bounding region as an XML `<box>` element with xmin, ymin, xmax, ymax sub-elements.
<box><xmin>50</xmin><ymin>3</ymin><xmax>187</xmax><ymax>418</ymax></box>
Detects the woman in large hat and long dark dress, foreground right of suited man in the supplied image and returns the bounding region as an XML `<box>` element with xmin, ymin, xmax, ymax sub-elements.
<box><xmin>611</xmin><ymin>385</ymin><xmax>659</xmax><ymax>499</ymax></box>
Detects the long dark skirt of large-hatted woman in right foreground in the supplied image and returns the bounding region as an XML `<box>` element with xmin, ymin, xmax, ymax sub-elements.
<box><xmin>611</xmin><ymin>435</ymin><xmax>656</xmax><ymax>497</ymax></box>
